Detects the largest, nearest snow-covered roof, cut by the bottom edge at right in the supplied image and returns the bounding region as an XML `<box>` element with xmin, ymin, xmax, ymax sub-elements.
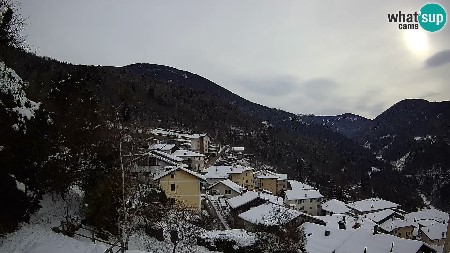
<box><xmin>302</xmin><ymin>223</ymin><xmax>429</xmax><ymax>253</ymax></box>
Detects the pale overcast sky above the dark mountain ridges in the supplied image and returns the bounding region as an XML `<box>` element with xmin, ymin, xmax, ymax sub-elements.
<box><xmin>20</xmin><ymin>0</ymin><xmax>450</xmax><ymax>118</ymax></box>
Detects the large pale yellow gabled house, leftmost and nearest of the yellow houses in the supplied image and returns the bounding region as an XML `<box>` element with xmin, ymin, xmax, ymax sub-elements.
<box><xmin>154</xmin><ymin>167</ymin><xmax>204</xmax><ymax>212</ymax></box>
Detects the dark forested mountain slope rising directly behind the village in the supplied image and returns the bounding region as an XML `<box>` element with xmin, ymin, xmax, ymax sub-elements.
<box><xmin>2</xmin><ymin>48</ymin><xmax>448</xmax><ymax>209</ymax></box>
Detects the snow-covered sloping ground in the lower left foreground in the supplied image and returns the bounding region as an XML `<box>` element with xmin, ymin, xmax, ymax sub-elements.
<box><xmin>0</xmin><ymin>187</ymin><xmax>218</xmax><ymax>253</ymax></box>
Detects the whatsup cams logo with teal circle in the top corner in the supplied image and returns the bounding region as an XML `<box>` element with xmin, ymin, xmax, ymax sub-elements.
<box><xmin>388</xmin><ymin>3</ymin><xmax>447</xmax><ymax>32</ymax></box>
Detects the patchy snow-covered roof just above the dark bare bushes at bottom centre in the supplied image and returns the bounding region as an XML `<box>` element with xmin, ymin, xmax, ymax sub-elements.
<box><xmin>239</xmin><ymin>203</ymin><xmax>301</xmax><ymax>226</ymax></box>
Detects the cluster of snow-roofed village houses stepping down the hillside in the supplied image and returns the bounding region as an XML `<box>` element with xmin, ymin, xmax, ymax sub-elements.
<box><xmin>136</xmin><ymin>129</ymin><xmax>450</xmax><ymax>253</ymax></box>
